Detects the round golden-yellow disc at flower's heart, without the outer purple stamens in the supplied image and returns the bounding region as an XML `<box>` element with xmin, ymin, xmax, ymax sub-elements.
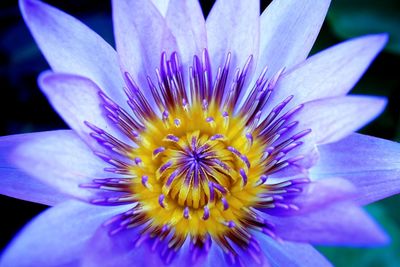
<box><xmin>130</xmin><ymin>99</ymin><xmax>266</xmax><ymax>240</ymax></box>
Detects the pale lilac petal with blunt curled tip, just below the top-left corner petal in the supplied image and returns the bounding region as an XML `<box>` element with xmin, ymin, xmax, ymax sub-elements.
<box><xmin>39</xmin><ymin>72</ymin><xmax>130</xmax><ymax>150</ymax></box>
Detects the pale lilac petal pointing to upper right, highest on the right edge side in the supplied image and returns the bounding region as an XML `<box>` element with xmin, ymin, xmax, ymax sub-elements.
<box><xmin>271</xmin><ymin>34</ymin><xmax>388</xmax><ymax>110</ymax></box>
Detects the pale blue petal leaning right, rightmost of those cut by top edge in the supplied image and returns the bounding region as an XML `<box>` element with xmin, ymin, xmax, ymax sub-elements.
<box><xmin>256</xmin><ymin>0</ymin><xmax>330</xmax><ymax>77</ymax></box>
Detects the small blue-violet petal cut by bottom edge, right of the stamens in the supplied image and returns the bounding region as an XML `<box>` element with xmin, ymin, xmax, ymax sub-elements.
<box><xmin>256</xmin><ymin>233</ymin><xmax>332</xmax><ymax>267</ymax></box>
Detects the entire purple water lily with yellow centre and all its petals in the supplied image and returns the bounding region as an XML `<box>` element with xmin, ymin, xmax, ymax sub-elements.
<box><xmin>0</xmin><ymin>0</ymin><xmax>400</xmax><ymax>266</ymax></box>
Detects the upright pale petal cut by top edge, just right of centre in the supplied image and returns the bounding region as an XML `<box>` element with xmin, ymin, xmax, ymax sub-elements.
<box><xmin>206</xmin><ymin>0</ymin><xmax>260</xmax><ymax>77</ymax></box>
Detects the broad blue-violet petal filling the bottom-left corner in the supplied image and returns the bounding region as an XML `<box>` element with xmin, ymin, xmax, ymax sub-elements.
<box><xmin>0</xmin><ymin>201</ymin><xmax>126</xmax><ymax>267</ymax></box>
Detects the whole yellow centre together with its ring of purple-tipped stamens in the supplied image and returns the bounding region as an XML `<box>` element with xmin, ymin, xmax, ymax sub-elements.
<box><xmin>81</xmin><ymin>50</ymin><xmax>310</xmax><ymax>263</ymax></box>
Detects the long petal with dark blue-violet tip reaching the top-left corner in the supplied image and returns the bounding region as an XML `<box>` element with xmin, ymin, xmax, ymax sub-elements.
<box><xmin>19</xmin><ymin>0</ymin><xmax>126</xmax><ymax>109</ymax></box>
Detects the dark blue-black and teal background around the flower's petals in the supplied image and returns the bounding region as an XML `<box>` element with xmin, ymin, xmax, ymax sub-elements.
<box><xmin>0</xmin><ymin>0</ymin><xmax>400</xmax><ymax>267</ymax></box>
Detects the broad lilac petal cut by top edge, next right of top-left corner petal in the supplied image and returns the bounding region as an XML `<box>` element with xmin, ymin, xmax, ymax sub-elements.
<box><xmin>112</xmin><ymin>0</ymin><xmax>178</xmax><ymax>110</ymax></box>
